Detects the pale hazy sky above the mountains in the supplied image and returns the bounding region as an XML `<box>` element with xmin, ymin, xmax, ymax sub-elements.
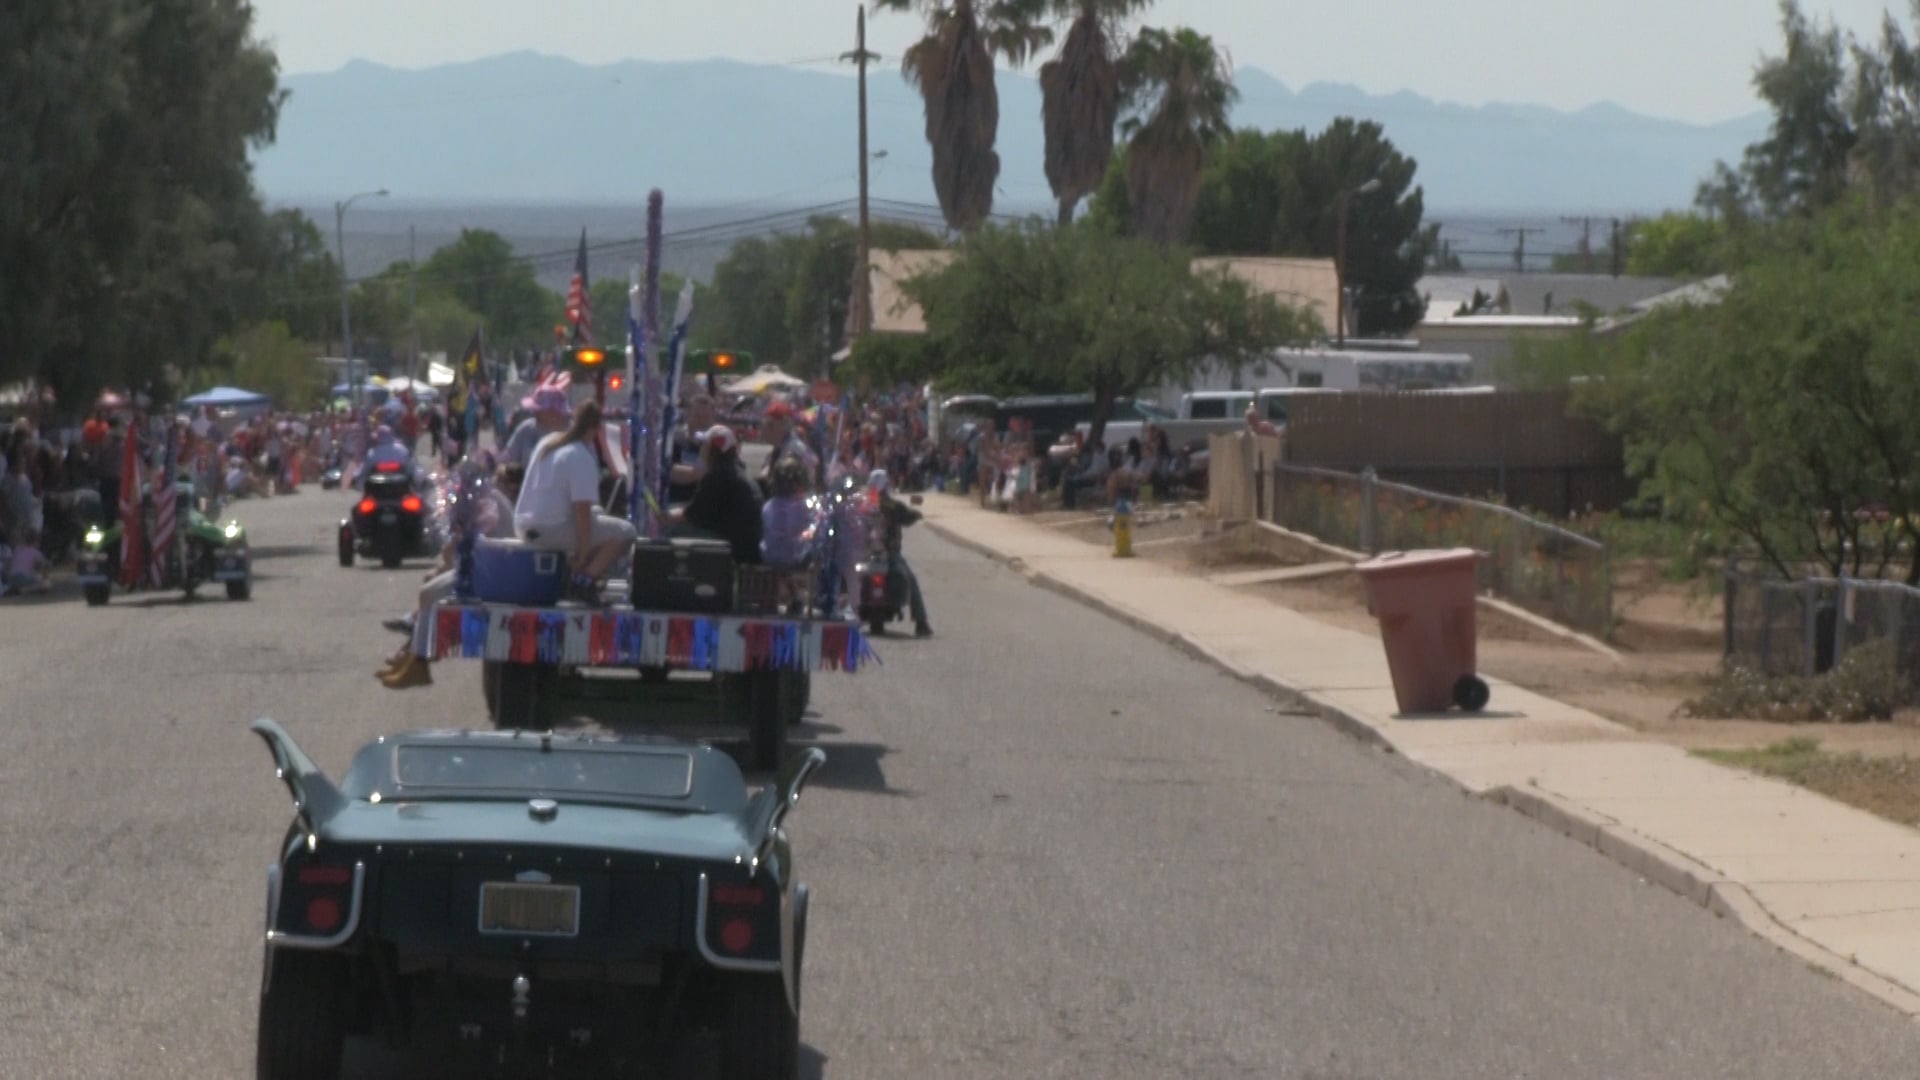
<box><xmin>253</xmin><ymin>0</ymin><xmax>1907</xmax><ymax>121</ymax></box>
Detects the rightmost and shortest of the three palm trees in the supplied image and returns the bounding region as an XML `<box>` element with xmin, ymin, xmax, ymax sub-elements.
<box><xmin>1119</xmin><ymin>27</ymin><xmax>1240</xmax><ymax>246</ymax></box>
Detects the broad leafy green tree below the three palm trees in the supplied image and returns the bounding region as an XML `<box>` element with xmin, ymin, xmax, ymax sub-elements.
<box><xmin>904</xmin><ymin>223</ymin><xmax>1317</xmax><ymax>438</ymax></box>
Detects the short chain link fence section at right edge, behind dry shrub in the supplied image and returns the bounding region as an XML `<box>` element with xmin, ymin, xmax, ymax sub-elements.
<box><xmin>1726</xmin><ymin>565</ymin><xmax>1920</xmax><ymax>676</ymax></box>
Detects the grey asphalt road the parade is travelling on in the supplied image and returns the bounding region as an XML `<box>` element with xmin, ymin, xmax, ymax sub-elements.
<box><xmin>0</xmin><ymin>490</ymin><xmax>1920</xmax><ymax>1080</ymax></box>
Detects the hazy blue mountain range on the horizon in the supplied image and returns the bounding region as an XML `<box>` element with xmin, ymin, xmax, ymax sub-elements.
<box><xmin>257</xmin><ymin>52</ymin><xmax>1766</xmax><ymax>219</ymax></box>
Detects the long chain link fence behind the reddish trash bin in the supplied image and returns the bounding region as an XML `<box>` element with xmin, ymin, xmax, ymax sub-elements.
<box><xmin>1261</xmin><ymin>463</ymin><xmax>1613</xmax><ymax>638</ymax></box>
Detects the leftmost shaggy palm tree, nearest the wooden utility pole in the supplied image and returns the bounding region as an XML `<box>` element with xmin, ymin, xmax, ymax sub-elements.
<box><xmin>874</xmin><ymin>0</ymin><xmax>1054</xmax><ymax>233</ymax></box>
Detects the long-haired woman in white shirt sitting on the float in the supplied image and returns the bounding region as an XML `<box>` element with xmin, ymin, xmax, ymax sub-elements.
<box><xmin>513</xmin><ymin>402</ymin><xmax>636</xmax><ymax>603</ymax></box>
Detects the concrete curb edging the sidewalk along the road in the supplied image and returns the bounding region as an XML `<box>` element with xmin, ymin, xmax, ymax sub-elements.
<box><xmin>925</xmin><ymin>519</ymin><xmax>1920</xmax><ymax>1019</ymax></box>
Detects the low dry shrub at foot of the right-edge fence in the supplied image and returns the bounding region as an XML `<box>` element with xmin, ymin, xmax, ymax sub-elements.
<box><xmin>1682</xmin><ymin>640</ymin><xmax>1914</xmax><ymax>723</ymax></box>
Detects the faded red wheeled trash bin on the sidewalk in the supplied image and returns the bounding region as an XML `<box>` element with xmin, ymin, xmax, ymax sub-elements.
<box><xmin>1354</xmin><ymin>548</ymin><xmax>1488</xmax><ymax>713</ymax></box>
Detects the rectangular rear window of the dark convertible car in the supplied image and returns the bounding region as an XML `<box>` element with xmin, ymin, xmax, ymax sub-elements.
<box><xmin>394</xmin><ymin>746</ymin><xmax>693</xmax><ymax>799</ymax></box>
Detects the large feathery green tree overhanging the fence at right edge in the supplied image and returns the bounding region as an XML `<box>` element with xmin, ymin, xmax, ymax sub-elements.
<box><xmin>1549</xmin><ymin>204</ymin><xmax>1920</xmax><ymax>584</ymax></box>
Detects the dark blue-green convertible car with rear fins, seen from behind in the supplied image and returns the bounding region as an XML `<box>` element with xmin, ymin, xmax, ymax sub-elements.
<box><xmin>253</xmin><ymin>721</ymin><xmax>826</xmax><ymax>1080</ymax></box>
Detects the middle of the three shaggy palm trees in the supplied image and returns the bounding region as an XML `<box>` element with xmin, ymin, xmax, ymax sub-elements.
<box><xmin>1041</xmin><ymin>0</ymin><xmax>1152</xmax><ymax>225</ymax></box>
